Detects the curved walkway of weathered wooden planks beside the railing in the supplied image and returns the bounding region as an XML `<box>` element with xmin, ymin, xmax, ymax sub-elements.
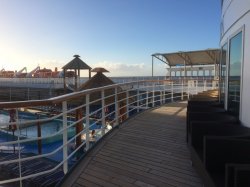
<box><xmin>62</xmin><ymin>102</ymin><xmax>202</xmax><ymax>187</ymax></box>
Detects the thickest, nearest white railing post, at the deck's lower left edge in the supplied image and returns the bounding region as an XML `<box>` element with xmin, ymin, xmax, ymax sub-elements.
<box><xmin>62</xmin><ymin>101</ymin><xmax>68</xmax><ymax>174</ymax></box>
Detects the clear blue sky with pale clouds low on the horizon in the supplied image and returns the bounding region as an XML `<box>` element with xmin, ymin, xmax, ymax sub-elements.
<box><xmin>0</xmin><ymin>0</ymin><xmax>220</xmax><ymax>76</ymax></box>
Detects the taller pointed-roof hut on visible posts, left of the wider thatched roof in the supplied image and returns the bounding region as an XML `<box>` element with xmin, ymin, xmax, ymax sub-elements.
<box><xmin>62</xmin><ymin>55</ymin><xmax>92</xmax><ymax>90</ymax></box>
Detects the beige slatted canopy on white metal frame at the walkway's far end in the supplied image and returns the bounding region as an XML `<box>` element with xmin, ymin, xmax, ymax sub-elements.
<box><xmin>152</xmin><ymin>49</ymin><xmax>220</xmax><ymax>77</ymax></box>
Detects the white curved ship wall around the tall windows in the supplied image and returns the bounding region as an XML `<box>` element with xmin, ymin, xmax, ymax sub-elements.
<box><xmin>221</xmin><ymin>0</ymin><xmax>250</xmax><ymax>127</ymax></box>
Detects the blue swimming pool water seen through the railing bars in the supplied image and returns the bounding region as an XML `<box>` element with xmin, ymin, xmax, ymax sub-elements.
<box><xmin>0</xmin><ymin>111</ymin><xmax>101</xmax><ymax>161</ymax></box>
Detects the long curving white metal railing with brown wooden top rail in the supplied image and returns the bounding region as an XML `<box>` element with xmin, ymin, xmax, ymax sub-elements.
<box><xmin>0</xmin><ymin>80</ymin><xmax>217</xmax><ymax>185</ymax></box>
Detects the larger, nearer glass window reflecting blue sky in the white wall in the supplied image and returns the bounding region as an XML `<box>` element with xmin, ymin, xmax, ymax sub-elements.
<box><xmin>228</xmin><ymin>32</ymin><xmax>242</xmax><ymax>117</ymax></box>
